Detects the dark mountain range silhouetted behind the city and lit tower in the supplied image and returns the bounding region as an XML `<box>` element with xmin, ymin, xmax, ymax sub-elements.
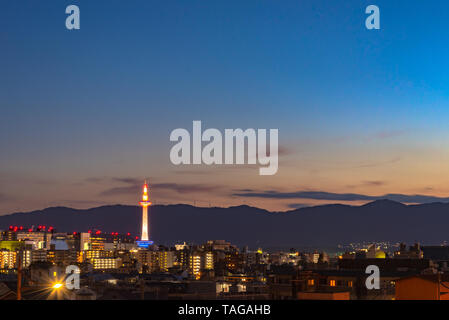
<box><xmin>0</xmin><ymin>200</ymin><xmax>449</xmax><ymax>247</ymax></box>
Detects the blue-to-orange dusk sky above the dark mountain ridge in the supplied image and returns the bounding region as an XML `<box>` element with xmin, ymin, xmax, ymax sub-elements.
<box><xmin>0</xmin><ymin>0</ymin><xmax>449</xmax><ymax>214</ymax></box>
